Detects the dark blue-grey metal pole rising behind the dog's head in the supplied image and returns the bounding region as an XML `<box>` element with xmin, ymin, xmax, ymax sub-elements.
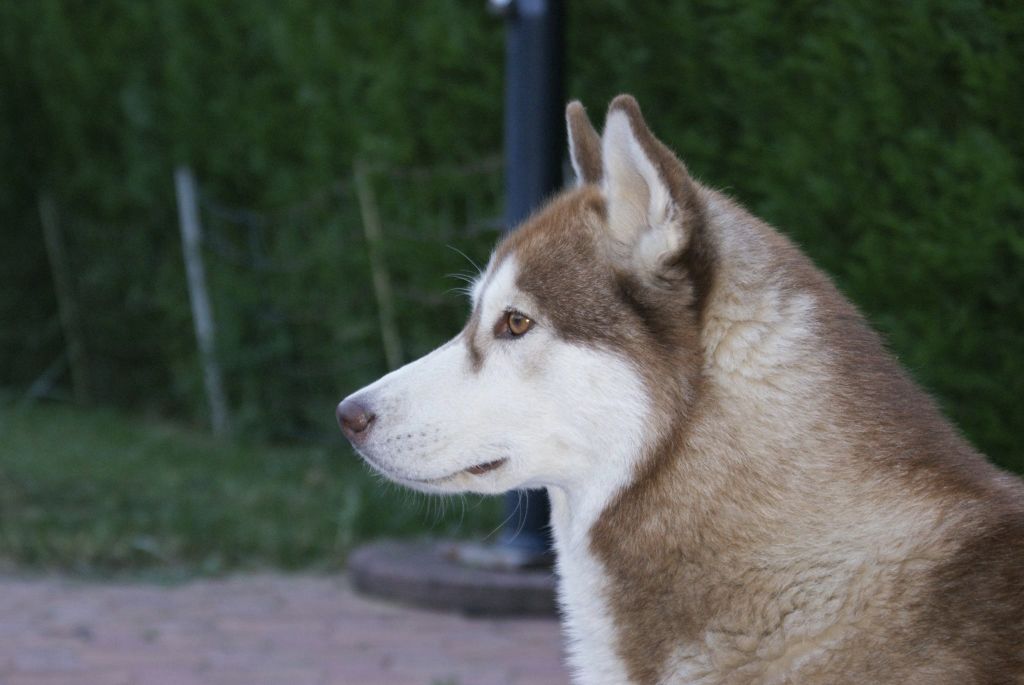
<box><xmin>489</xmin><ymin>0</ymin><xmax>565</xmax><ymax>565</ymax></box>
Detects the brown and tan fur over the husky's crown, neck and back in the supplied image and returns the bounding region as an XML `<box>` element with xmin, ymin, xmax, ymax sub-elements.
<box><xmin>496</xmin><ymin>96</ymin><xmax>1024</xmax><ymax>684</ymax></box>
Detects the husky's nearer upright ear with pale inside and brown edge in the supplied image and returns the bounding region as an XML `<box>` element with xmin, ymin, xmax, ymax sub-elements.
<box><xmin>601</xmin><ymin>95</ymin><xmax>703</xmax><ymax>284</ymax></box>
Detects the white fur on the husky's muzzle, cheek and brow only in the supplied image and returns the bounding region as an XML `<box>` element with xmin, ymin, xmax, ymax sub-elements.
<box><xmin>342</xmin><ymin>252</ymin><xmax>647</xmax><ymax>491</ymax></box>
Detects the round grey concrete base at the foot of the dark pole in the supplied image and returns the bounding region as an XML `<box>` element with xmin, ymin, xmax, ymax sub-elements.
<box><xmin>348</xmin><ymin>541</ymin><xmax>555</xmax><ymax>616</ymax></box>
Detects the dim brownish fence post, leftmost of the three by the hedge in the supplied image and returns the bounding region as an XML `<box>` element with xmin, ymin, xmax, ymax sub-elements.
<box><xmin>39</xmin><ymin>192</ymin><xmax>91</xmax><ymax>404</ymax></box>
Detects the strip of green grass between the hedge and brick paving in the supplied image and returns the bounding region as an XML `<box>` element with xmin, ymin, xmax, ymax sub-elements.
<box><xmin>0</xmin><ymin>405</ymin><xmax>500</xmax><ymax>574</ymax></box>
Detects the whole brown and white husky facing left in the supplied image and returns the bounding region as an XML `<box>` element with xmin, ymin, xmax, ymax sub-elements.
<box><xmin>337</xmin><ymin>95</ymin><xmax>1024</xmax><ymax>685</ymax></box>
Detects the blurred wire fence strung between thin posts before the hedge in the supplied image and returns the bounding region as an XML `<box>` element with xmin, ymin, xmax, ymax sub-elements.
<box><xmin>27</xmin><ymin>157</ymin><xmax>503</xmax><ymax>438</ymax></box>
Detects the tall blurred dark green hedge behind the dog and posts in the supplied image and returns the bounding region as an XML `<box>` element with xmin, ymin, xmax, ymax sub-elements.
<box><xmin>0</xmin><ymin>0</ymin><xmax>1024</xmax><ymax>569</ymax></box>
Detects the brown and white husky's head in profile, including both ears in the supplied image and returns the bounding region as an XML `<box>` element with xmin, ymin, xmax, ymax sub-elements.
<box><xmin>337</xmin><ymin>96</ymin><xmax>713</xmax><ymax>493</ymax></box>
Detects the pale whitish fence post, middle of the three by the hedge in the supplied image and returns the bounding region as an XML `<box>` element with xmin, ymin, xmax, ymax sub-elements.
<box><xmin>174</xmin><ymin>167</ymin><xmax>230</xmax><ymax>435</ymax></box>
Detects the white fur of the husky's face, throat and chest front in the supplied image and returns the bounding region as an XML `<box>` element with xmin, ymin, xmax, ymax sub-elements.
<box><xmin>339</xmin><ymin>253</ymin><xmax>650</xmax><ymax>685</ymax></box>
